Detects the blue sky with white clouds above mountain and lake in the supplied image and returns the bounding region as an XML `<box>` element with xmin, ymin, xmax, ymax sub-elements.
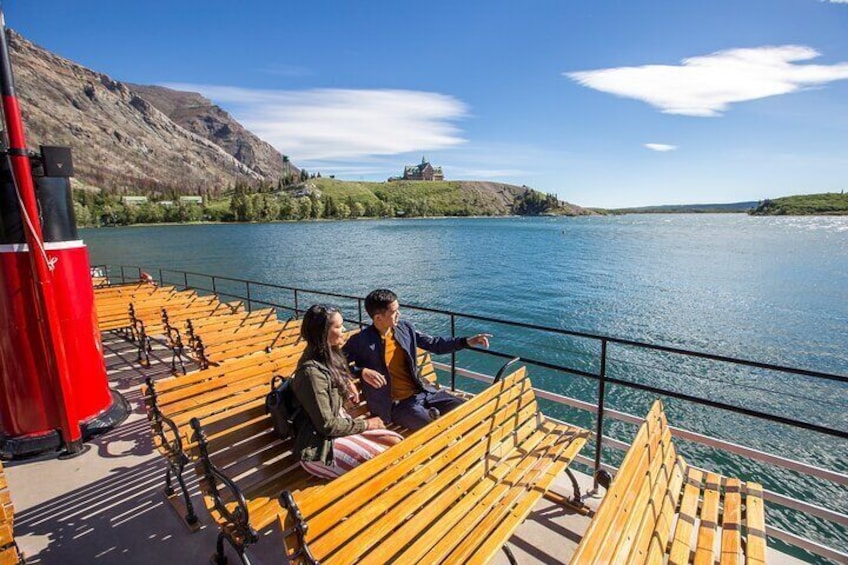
<box><xmin>3</xmin><ymin>0</ymin><xmax>848</xmax><ymax>207</ymax></box>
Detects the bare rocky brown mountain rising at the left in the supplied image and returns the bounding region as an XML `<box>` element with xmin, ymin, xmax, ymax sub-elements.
<box><xmin>9</xmin><ymin>31</ymin><xmax>290</xmax><ymax>198</ymax></box>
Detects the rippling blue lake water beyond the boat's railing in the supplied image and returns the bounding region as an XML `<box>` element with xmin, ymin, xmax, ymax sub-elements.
<box><xmin>82</xmin><ymin>215</ymin><xmax>848</xmax><ymax>560</ymax></box>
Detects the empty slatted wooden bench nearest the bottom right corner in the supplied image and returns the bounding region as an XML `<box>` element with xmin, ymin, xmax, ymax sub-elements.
<box><xmin>571</xmin><ymin>400</ymin><xmax>766</xmax><ymax>565</ymax></box>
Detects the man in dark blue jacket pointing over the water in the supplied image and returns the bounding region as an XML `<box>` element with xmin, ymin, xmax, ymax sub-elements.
<box><xmin>344</xmin><ymin>289</ymin><xmax>492</xmax><ymax>430</ymax></box>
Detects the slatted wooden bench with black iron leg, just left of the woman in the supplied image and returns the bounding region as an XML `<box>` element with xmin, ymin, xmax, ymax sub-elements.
<box><xmin>141</xmin><ymin>345</ymin><xmax>303</xmax><ymax>529</ymax></box>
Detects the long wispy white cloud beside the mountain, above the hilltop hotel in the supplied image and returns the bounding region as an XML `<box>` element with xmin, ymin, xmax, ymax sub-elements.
<box><xmin>164</xmin><ymin>84</ymin><xmax>468</xmax><ymax>162</ymax></box>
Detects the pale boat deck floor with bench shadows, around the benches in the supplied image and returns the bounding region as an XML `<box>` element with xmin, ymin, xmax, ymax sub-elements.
<box><xmin>6</xmin><ymin>334</ymin><xmax>801</xmax><ymax>565</ymax></box>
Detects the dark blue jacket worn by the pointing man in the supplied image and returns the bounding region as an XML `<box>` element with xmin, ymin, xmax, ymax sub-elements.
<box><xmin>344</xmin><ymin>320</ymin><xmax>467</xmax><ymax>423</ymax></box>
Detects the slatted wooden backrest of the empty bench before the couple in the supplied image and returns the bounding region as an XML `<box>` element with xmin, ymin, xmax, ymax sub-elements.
<box><xmin>282</xmin><ymin>368</ymin><xmax>546</xmax><ymax>563</ymax></box>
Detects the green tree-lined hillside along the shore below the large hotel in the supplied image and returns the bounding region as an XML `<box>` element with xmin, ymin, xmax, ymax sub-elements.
<box><xmin>74</xmin><ymin>175</ymin><xmax>595</xmax><ymax>226</ymax></box>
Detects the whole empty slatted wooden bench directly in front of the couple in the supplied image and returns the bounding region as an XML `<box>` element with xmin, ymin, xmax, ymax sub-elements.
<box><xmin>280</xmin><ymin>368</ymin><xmax>589</xmax><ymax>564</ymax></box>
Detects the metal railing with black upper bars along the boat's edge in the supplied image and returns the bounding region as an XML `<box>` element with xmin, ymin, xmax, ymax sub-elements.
<box><xmin>97</xmin><ymin>266</ymin><xmax>848</xmax><ymax>562</ymax></box>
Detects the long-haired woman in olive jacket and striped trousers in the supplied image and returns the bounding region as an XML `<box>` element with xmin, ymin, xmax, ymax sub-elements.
<box><xmin>292</xmin><ymin>304</ymin><xmax>403</xmax><ymax>479</ymax></box>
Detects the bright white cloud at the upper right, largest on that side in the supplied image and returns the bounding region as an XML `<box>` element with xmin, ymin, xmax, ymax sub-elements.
<box><xmin>563</xmin><ymin>45</ymin><xmax>848</xmax><ymax>117</ymax></box>
